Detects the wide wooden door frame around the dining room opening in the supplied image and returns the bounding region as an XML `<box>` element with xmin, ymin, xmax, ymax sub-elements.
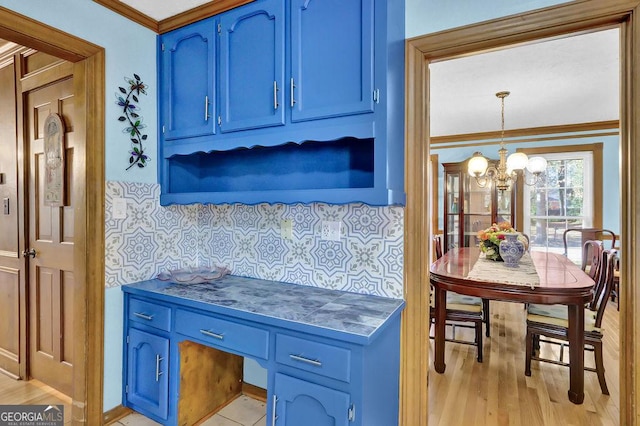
<box><xmin>401</xmin><ymin>0</ymin><xmax>640</xmax><ymax>425</ymax></box>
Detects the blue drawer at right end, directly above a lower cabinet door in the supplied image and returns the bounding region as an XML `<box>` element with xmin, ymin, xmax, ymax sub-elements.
<box><xmin>276</xmin><ymin>334</ymin><xmax>351</xmax><ymax>383</ymax></box>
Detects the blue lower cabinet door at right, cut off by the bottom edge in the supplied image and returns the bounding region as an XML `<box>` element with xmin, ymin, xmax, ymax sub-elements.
<box><xmin>274</xmin><ymin>373</ymin><xmax>350</xmax><ymax>426</ymax></box>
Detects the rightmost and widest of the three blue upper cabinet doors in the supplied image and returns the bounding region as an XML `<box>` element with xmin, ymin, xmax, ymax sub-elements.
<box><xmin>289</xmin><ymin>0</ymin><xmax>374</xmax><ymax>122</ymax></box>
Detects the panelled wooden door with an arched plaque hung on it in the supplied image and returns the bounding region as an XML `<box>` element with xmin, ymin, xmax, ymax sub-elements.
<box><xmin>24</xmin><ymin>78</ymin><xmax>74</xmax><ymax>395</ymax></box>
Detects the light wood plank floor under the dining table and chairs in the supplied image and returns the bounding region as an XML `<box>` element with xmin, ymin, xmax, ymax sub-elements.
<box><xmin>429</xmin><ymin>301</ymin><xmax>620</xmax><ymax>426</ymax></box>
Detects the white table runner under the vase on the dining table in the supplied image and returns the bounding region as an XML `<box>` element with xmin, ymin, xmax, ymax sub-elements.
<box><xmin>467</xmin><ymin>253</ymin><xmax>540</xmax><ymax>289</ymax></box>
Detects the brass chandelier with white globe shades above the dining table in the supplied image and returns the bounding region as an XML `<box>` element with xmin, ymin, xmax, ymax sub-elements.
<box><xmin>467</xmin><ymin>91</ymin><xmax>547</xmax><ymax>191</ymax></box>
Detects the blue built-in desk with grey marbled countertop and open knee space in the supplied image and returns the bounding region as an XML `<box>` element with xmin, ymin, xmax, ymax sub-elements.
<box><xmin>122</xmin><ymin>275</ymin><xmax>404</xmax><ymax>426</ymax></box>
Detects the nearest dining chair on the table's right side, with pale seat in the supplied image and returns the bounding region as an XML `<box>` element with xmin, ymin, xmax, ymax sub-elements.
<box><xmin>524</xmin><ymin>249</ymin><xmax>618</xmax><ymax>395</ymax></box>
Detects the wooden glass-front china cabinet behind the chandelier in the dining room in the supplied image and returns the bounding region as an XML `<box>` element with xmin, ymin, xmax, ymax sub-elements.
<box><xmin>442</xmin><ymin>161</ymin><xmax>516</xmax><ymax>252</ymax></box>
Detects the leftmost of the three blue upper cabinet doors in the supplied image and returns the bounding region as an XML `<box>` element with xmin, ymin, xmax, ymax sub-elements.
<box><xmin>160</xmin><ymin>19</ymin><xmax>216</xmax><ymax>140</ymax></box>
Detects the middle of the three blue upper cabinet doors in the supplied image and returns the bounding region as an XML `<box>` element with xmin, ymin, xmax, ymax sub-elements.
<box><xmin>219</xmin><ymin>0</ymin><xmax>285</xmax><ymax>133</ymax></box>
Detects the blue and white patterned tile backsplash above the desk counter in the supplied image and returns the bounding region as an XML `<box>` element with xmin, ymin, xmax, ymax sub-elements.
<box><xmin>105</xmin><ymin>182</ymin><xmax>404</xmax><ymax>298</ymax></box>
